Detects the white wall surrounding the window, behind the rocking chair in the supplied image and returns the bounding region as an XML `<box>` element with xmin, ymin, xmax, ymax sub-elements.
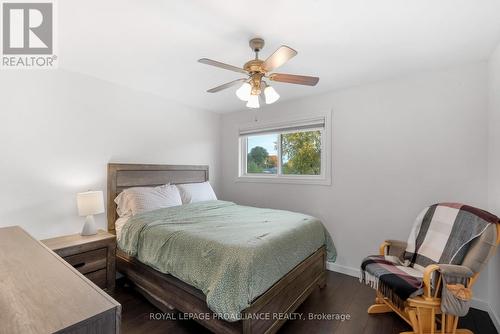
<box><xmin>222</xmin><ymin>63</ymin><xmax>488</xmax><ymax>299</ymax></box>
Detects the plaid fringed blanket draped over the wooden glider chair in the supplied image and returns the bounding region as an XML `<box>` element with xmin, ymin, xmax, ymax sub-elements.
<box><xmin>360</xmin><ymin>203</ymin><xmax>500</xmax><ymax>308</ymax></box>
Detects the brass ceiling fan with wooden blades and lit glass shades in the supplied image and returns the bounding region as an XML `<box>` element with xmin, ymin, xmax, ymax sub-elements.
<box><xmin>198</xmin><ymin>38</ymin><xmax>319</xmax><ymax>108</ymax></box>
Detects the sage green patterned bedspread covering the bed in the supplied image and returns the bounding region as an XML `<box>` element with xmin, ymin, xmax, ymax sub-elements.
<box><xmin>118</xmin><ymin>201</ymin><xmax>336</xmax><ymax>321</ymax></box>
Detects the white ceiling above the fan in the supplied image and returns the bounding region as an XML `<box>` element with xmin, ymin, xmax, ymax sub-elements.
<box><xmin>58</xmin><ymin>0</ymin><xmax>500</xmax><ymax>112</ymax></box>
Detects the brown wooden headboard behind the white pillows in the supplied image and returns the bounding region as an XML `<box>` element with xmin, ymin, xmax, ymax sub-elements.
<box><xmin>107</xmin><ymin>163</ymin><xmax>208</xmax><ymax>233</ymax></box>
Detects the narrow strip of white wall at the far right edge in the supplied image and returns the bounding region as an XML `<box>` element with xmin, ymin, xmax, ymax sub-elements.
<box><xmin>488</xmin><ymin>44</ymin><xmax>500</xmax><ymax>331</ymax></box>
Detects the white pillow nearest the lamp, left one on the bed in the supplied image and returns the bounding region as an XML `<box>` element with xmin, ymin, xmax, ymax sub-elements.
<box><xmin>115</xmin><ymin>184</ymin><xmax>182</xmax><ymax>217</ymax></box>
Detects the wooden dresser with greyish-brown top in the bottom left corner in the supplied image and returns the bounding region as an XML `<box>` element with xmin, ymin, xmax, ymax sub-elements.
<box><xmin>0</xmin><ymin>226</ymin><xmax>121</xmax><ymax>334</ymax></box>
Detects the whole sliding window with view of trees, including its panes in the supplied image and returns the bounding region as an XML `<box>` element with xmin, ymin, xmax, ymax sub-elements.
<box><xmin>238</xmin><ymin>113</ymin><xmax>330</xmax><ymax>184</ymax></box>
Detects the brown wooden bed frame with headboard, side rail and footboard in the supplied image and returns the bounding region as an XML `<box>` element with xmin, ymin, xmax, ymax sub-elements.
<box><xmin>107</xmin><ymin>163</ymin><xmax>326</xmax><ymax>334</ymax></box>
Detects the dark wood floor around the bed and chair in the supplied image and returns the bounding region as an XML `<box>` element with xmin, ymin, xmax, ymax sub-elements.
<box><xmin>113</xmin><ymin>272</ymin><xmax>497</xmax><ymax>334</ymax></box>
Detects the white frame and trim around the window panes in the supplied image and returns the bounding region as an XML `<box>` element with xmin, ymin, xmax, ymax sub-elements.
<box><xmin>236</xmin><ymin>111</ymin><xmax>332</xmax><ymax>185</ymax></box>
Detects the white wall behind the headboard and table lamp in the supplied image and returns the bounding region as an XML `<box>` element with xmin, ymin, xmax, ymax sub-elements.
<box><xmin>0</xmin><ymin>70</ymin><xmax>220</xmax><ymax>238</ymax></box>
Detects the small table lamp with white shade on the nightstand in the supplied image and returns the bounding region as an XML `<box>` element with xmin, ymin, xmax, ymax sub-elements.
<box><xmin>76</xmin><ymin>191</ymin><xmax>104</xmax><ymax>235</ymax></box>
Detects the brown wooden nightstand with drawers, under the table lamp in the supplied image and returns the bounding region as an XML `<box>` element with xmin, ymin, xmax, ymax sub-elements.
<box><xmin>42</xmin><ymin>230</ymin><xmax>116</xmax><ymax>291</ymax></box>
